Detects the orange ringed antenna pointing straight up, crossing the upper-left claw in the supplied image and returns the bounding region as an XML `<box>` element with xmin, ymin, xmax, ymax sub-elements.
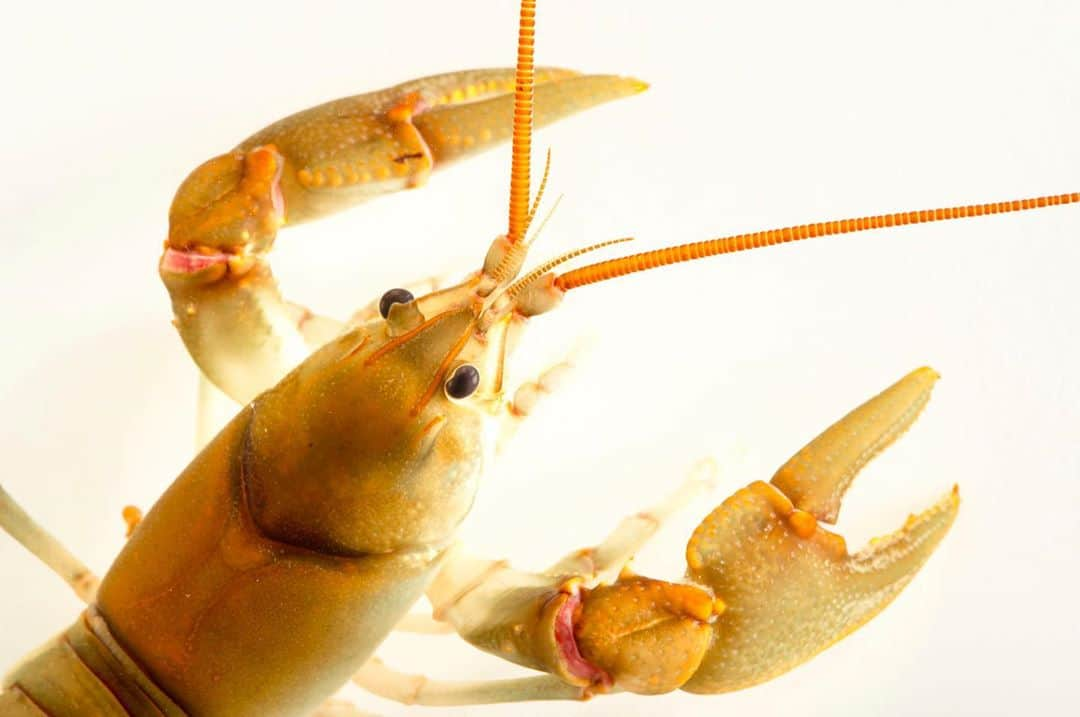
<box><xmin>507</xmin><ymin>0</ymin><xmax>537</xmax><ymax>244</ymax></box>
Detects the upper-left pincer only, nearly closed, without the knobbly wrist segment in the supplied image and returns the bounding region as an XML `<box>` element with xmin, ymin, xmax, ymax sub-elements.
<box><xmin>238</xmin><ymin>68</ymin><xmax>645</xmax><ymax>224</ymax></box>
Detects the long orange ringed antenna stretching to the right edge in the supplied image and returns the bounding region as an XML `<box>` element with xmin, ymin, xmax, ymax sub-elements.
<box><xmin>555</xmin><ymin>192</ymin><xmax>1080</xmax><ymax>292</ymax></box>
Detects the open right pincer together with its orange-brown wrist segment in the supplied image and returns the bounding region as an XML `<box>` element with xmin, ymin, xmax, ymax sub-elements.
<box><xmin>561</xmin><ymin>368</ymin><xmax>960</xmax><ymax>693</ymax></box>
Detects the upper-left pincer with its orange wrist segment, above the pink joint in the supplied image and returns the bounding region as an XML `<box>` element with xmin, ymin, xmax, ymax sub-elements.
<box><xmin>168</xmin><ymin>68</ymin><xmax>648</xmax><ymax>254</ymax></box>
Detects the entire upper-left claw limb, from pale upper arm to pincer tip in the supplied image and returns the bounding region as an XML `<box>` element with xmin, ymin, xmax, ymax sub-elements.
<box><xmin>159</xmin><ymin>68</ymin><xmax>647</xmax><ymax>403</ymax></box>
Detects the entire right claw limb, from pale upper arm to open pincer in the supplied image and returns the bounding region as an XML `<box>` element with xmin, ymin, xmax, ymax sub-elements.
<box><xmin>428</xmin><ymin>368</ymin><xmax>960</xmax><ymax>696</ymax></box>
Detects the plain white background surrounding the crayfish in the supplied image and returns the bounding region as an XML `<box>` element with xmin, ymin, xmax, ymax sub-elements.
<box><xmin>0</xmin><ymin>0</ymin><xmax>1080</xmax><ymax>716</ymax></box>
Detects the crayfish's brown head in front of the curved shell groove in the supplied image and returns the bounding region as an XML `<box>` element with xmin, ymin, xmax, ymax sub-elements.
<box><xmin>245</xmin><ymin>298</ymin><xmax>518</xmax><ymax>555</ymax></box>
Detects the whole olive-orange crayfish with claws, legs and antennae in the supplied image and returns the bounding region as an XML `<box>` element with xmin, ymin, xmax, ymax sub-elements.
<box><xmin>0</xmin><ymin>0</ymin><xmax>1080</xmax><ymax>715</ymax></box>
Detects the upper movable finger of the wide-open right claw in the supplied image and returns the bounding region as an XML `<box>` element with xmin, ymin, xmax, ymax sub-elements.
<box><xmin>771</xmin><ymin>366</ymin><xmax>939</xmax><ymax>523</ymax></box>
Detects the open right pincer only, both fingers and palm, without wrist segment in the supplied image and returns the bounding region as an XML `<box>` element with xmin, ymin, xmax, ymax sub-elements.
<box><xmin>684</xmin><ymin>368</ymin><xmax>959</xmax><ymax>693</ymax></box>
